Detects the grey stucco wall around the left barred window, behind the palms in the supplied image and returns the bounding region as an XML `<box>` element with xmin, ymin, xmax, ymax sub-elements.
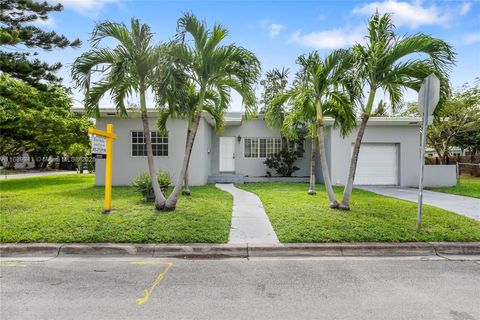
<box><xmin>95</xmin><ymin>117</ymin><xmax>211</xmax><ymax>186</ymax></box>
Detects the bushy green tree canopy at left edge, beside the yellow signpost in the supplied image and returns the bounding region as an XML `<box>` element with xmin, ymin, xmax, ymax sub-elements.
<box><xmin>0</xmin><ymin>74</ymin><xmax>93</xmax><ymax>165</ymax></box>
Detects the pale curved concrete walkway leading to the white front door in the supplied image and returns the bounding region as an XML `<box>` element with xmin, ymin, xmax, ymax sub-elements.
<box><xmin>215</xmin><ymin>183</ymin><xmax>279</xmax><ymax>244</ymax></box>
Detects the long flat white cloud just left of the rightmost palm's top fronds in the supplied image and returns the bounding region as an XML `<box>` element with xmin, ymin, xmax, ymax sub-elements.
<box><xmin>289</xmin><ymin>27</ymin><xmax>365</xmax><ymax>49</ymax></box>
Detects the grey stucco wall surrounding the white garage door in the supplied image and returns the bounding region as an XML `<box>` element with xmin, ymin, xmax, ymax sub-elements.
<box><xmin>330</xmin><ymin>124</ymin><xmax>420</xmax><ymax>186</ymax></box>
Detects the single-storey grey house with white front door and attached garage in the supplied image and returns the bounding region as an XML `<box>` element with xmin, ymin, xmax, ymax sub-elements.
<box><xmin>76</xmin><ymin>109</ymin><xmax>420</xmax><ymax>186</ymax></box>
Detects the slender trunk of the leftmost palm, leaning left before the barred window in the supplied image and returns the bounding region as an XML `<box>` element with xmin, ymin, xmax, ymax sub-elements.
<box><xmin>140</xmin><ymin>92</ymin><xmax>165</xmax><ymax>210</ymax></box>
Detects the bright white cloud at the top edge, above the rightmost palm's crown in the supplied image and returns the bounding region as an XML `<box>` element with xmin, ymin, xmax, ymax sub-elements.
<box><xmin>353</xmin><ymin>0</ymin><xmax>450</xmax><ymax>29</ymax></box>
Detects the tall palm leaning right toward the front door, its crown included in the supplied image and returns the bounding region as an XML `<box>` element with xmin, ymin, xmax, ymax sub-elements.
<box><xmin>165</xmin><ymin>14</ymin><xmax>260</xmax><ymax>210</ymax></box>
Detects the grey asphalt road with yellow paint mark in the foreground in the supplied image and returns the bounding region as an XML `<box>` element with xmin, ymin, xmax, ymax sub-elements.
<box><xmin>0</xmin><ymin>258</ymin><xmax>480</xmax><ymax>320</ymax></box>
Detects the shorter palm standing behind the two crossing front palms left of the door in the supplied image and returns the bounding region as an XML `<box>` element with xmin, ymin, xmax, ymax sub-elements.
<box><xmin>157</xmin><ymin>81</ymin><xmax>228</xmax><ymax>196</ymax></box>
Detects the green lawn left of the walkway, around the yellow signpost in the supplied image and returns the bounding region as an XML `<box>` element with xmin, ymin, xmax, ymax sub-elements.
<box><xmin>0</xmin><ymin>174</ymin><xmax>232</xmax><ymax>243</ymax></box>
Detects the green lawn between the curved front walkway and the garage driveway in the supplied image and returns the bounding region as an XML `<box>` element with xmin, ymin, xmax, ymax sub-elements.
<box><xmin>238</xmin><ymin>183</ymin><xmax>480</xmax><ymax>242</ymax></box>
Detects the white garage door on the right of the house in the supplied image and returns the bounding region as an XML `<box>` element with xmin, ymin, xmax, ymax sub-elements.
<box><xmin>354</xmin><ymin>143</ymin><xmax>398</xmax><ymax>185</ymax></box>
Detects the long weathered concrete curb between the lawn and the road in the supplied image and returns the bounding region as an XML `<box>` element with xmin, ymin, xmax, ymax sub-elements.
<box><xmin>0</xmin><ymin>242</ymin><xmax>480</xmax><ymax>259</ymax></box>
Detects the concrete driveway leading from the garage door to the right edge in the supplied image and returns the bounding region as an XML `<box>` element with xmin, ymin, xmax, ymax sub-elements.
<box><xmin>356</xmin><ymin>186</ymin><xmax>480</xmax><ymax>221</ymax></box>
